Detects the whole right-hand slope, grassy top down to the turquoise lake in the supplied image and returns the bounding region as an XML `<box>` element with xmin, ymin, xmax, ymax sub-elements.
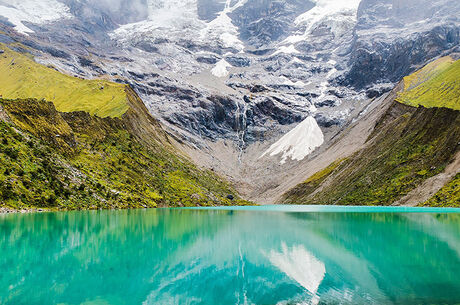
<box><xmin>282</xmin><ymin>58</ymin><xmax>460</xmax><ymax>205</ymax></box>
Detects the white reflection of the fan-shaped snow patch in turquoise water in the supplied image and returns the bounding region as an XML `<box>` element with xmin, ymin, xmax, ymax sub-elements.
<box><xmin>267</xmin><ymin>243</ymin><xmax>326</xmax><ymax>303</ymax></box>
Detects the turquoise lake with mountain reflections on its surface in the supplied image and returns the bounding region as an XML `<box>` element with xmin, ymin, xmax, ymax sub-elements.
<box><xmin>0</xmin><ymin>206</ymin><xmax>460</xmax><ymax>305</ymax></box>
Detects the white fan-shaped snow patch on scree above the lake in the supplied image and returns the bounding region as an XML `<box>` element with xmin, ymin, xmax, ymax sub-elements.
<box><xmin>260</xmin><ymin>116</ymin><xmax>324</xmax><ymax>164</ymax></box>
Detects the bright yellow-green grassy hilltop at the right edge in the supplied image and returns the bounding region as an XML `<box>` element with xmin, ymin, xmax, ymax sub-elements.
<box><xmin>397</xmin><ymin>56</ymin><xmax>460</xmax><ymax>110</ymax></box>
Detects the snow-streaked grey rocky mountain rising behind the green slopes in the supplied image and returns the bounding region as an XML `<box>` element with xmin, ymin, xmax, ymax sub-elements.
<box><xmin>0</xmin><ymin>0</ymin><xmax>460</xmax><ymax>201</ymax></box>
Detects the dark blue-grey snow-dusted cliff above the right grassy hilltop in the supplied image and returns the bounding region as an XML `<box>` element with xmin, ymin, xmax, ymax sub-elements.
<box><xmin>341</xmin><ymin>0</ymin><xmax>460</xmax><ymax>89</ymax></box>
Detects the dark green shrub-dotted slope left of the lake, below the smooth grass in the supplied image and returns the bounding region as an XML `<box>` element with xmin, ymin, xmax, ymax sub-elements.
<box><xmin>0</xmin><ymin>99</ymin><xmax>245</xmax><ymax>209</ymax></box>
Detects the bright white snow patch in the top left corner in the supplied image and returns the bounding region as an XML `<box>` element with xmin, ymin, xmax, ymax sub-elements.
<box><xmin>0</xmin><ymin>0</ymin><xmax>72</xmax><ymax>35</ymax></box>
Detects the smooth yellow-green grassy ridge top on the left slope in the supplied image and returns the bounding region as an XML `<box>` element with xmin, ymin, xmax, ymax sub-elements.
<box><xmin>0</xmin><ymin>44</ymin><xmax>128</xmax><ymax>117</ymax></box>
